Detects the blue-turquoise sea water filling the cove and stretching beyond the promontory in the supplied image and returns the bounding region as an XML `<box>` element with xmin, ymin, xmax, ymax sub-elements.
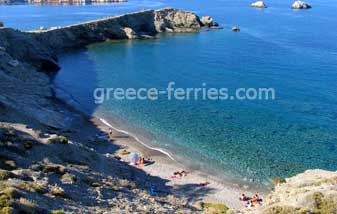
<box><xmin>0</xmin><ymin>0</ymin><xmax>337</xmax><ymax>187</ymax></box>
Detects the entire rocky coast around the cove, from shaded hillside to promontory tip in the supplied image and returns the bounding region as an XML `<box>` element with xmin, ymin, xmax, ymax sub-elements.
<box><xmin>0</xmin><ymin>8</ymin><xmax>337</xmax><ymax>213</ymax></box>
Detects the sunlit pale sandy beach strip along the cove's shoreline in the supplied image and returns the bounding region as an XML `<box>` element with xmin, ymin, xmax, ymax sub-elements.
<box><xmin>92</xmin><ymin>118</ymin><xmax>266</xmax><ymax>209</ymax></box>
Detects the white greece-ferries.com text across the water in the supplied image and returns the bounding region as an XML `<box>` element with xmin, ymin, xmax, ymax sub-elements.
<box><xmin>93</xmin><ymin>82</ymin><xmax>276</xmax><ymax>104</ymax></box>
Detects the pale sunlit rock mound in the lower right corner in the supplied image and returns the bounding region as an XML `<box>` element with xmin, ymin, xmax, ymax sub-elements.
<box><xmin>259</xmin><ymin>169</ymin><xmax>337</xmax><ymax>213</ymax></box>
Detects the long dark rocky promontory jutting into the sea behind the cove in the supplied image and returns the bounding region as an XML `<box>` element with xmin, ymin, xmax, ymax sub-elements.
<box><xmin>0</xmin><ymin>8</ymin><xmax>217</xmax><ymax>71</ymax></box>
